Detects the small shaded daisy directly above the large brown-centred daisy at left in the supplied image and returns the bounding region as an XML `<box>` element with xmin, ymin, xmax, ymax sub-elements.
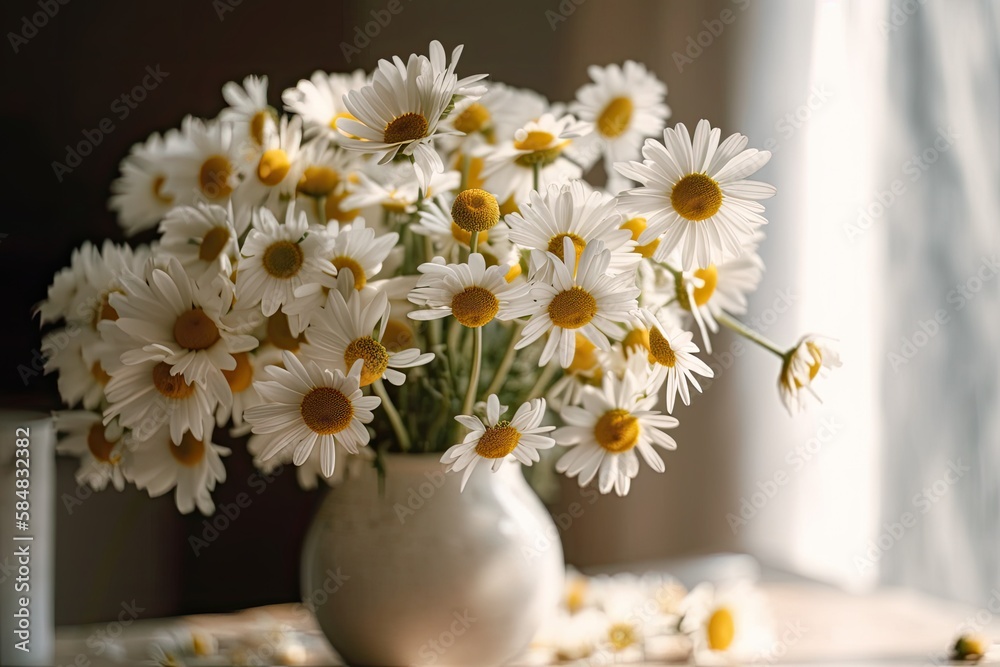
<box><xmin>160</xmin><ymin>204</ymin><xmax>240</xmax><ymax>283</ymax></box>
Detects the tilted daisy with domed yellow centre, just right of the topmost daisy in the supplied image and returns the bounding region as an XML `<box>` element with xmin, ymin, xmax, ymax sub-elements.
<box><xmin>482</xmin><ymin>113</ymin><xmax>587</xmax><ymax>204</ymax></box>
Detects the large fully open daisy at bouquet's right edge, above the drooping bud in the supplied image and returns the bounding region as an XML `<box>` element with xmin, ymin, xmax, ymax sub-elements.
<box><xmin>615</xmin><ymin>120</ymin><xmax>775</xmax><ymax>269</ymax></box>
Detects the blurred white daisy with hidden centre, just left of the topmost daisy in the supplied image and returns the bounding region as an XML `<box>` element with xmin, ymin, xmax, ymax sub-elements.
<box><xmin>281</xmin><ymin>69</ymin><xmax>368</xmax><ymax>144</ymax></box>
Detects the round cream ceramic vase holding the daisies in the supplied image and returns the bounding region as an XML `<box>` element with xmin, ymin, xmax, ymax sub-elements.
<box><xmin>302</xmin><ymin>455</ymin><xmax>564</xmax><ymax>667</ymax></box>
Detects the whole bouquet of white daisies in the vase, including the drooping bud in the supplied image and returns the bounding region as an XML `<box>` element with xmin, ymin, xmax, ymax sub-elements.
<box><xmin>38</xmin><ymin>41</ymin><xmax>839</xmax><ymax>513</ymax></box>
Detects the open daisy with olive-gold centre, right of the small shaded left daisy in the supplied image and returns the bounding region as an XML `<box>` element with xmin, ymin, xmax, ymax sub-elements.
<box><xmin>236</xmin><ymin>202</ymin><xmax>337</xmax><ymax>317</ymax></box>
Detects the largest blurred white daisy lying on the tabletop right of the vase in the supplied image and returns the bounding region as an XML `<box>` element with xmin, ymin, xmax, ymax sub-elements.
<box><xmin>680</xmin><ymin>582</ymin><xmax>772</xmax><ymax>665</ymax></box>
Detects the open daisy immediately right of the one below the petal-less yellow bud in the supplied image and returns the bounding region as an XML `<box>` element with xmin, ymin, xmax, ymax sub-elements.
<box><xmin>515</xmin><ymin>237</ymin><xmax>639</xmax><ymax>368</ymax></box>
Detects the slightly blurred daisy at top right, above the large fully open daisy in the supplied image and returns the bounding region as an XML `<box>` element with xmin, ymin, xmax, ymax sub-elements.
<box><xmin>570</xmin><ymin>60</ymin><xmax>670</xmax><ymax>175</ymax></box>
